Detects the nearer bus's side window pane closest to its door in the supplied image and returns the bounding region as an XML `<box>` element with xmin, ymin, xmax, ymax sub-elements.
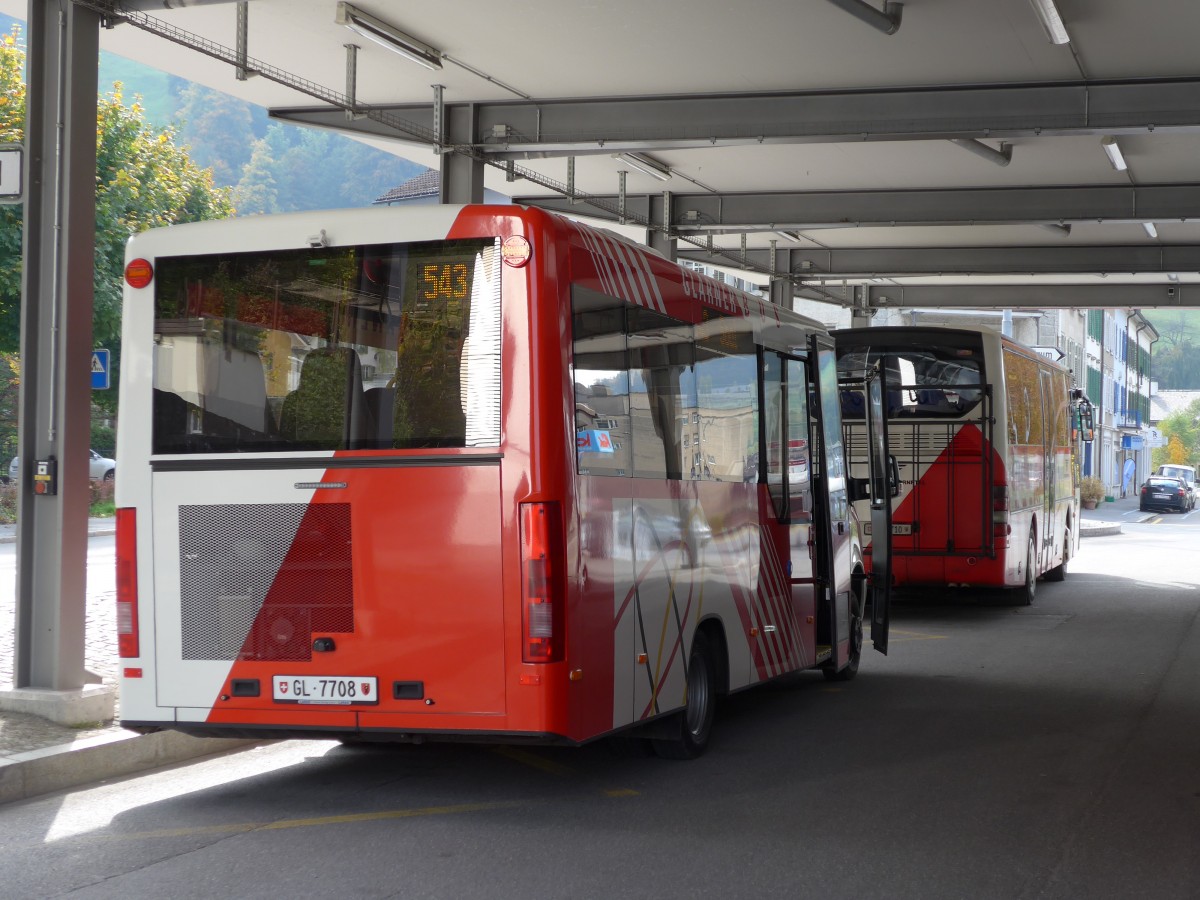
<box><xmin>696</xmin><ymin>310</ymin><xmax>758</xmax><ymax>482</ymax></box>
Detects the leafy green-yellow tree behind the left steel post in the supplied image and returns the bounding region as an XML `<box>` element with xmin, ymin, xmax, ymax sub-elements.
<box><xmin>0</xmin><ymin>28</ymin><xmax>234</xmax><ymax>436</ymax></box>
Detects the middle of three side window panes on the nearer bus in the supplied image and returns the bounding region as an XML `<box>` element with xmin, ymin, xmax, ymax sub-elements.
<box><xmin>625</xmin><ymin>306</ymin><xmax>703</xmax><ymax>481</ymax></box>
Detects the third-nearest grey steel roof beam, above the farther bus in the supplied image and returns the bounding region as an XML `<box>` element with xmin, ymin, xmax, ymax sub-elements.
<box><xmin>678</xmin><ymin>244</ymin><xmax>1200</xmax><ymax>278</ymax></box>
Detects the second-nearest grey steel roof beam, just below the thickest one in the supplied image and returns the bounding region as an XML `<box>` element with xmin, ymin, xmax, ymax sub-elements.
<box><xmin>514</xmin><ymin>184</ymin><xmax>1200</xmax><ymax>234</ymax></box>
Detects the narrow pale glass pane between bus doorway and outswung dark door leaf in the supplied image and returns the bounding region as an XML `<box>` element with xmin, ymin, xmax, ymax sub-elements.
<box><xmin>809</xmin><ymin>335</ymin><xmax>854</xmax><ymax>648</ymax></box>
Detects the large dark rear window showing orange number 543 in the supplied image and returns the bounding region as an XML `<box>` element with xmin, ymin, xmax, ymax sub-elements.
<box><xmin>152</xmin><ymin>240</ymin><xmax>500</xmax><ymax>454</ymax></box>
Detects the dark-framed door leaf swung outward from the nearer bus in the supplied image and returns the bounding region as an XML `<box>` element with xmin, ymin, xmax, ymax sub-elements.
<box><xmin>865</xmin><ymin>364</ymin><xmax>900</xmax><ymax>655</ymax></box>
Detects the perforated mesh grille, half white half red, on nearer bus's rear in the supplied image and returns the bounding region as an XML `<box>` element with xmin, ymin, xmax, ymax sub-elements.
<box><xmin>179</xmin><ymin>503</ymin><xmax>354</xmax><ymax>661</ymax></box>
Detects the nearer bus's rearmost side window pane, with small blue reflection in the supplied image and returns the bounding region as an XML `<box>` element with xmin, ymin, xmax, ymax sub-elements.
<box><xmin>571</xmin><ymin>286</ymin><xmax>632</xmax><ymax>475</ymax></box>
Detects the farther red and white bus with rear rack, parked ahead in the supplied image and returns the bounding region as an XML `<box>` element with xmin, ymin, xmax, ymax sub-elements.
<box><xmin>833</xmin><ymin>326</ymin><xmax>1090</xmax><ymax>605</ymax></box>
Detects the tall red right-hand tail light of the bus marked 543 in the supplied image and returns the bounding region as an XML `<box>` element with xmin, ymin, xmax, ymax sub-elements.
<box><xmin>521</xmin><ymin>503</ymin><xmax>566</xmax><ymax>662</ymax></box>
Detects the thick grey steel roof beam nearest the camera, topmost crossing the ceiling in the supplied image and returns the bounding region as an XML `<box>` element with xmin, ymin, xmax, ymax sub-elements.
<box><xmin>271</xmin><ymin>78</ymin><xmax>1200</xmax><ymax>160</ymax></box>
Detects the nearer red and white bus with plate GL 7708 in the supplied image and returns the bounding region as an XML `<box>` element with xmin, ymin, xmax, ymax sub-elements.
<box><xmin>116</xmin><ymin>200</ymin><xmax>886</xmax><ymax>757</ymax></box>
